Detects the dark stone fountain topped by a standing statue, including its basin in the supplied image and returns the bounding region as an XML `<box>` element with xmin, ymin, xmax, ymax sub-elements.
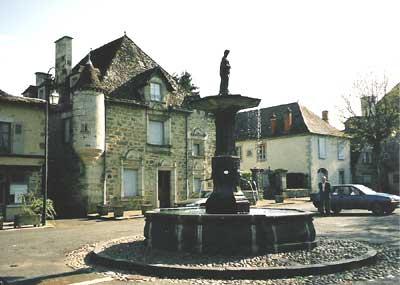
<box><xmin>144</xmin><ymin>50</ymin><xmax>316</xmax><ymax>254</ymax></box>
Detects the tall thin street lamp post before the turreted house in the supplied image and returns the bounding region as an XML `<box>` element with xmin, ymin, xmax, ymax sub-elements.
<box><xmin>42</xmin><ymin>67</ymin><xmax>54</xmax><ymax>226</ymax></box>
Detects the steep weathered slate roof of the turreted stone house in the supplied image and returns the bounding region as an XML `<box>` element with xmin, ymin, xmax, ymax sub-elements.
<box><xmin>71</xmin><ymin>35</ymin><xmax>185</xmax><ymax>105</ymax></box>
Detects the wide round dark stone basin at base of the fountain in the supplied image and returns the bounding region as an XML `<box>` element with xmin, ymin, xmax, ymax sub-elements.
<box><xmin>144</xmin><ymin>208</ymin><xmax>316</xmax><ymax>254</ymax></box>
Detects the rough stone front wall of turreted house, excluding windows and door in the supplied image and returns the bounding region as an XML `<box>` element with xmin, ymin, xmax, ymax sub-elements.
<box><xmin>106</xmin><ymin>102</ymin><xmax>215</xmax><ymax>208</ymax></box>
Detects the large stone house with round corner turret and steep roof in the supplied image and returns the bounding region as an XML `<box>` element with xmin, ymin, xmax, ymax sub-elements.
<box><xmin>21</xmin><ymin>35</ymin><xmax>215</xmax><ymax>216</ymax></box>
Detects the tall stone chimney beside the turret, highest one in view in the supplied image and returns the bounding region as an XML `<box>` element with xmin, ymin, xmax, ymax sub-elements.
<box><xmin>54</xmin><ymin>36</ymin><xmax>72</xmax><ymax>84</ymax></box>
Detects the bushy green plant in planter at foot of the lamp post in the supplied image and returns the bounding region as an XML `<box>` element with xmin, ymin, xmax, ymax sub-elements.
<box><xmin>14</xmin><ymin>193</ymin><xmax>56</xmax><ymax>228</ymax></box>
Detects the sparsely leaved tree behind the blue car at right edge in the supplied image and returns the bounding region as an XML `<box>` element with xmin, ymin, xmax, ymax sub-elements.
<box><xmin>343</xmin><ymin>75</ymin><xmax>400</xmax><ymax>190</ymax></box>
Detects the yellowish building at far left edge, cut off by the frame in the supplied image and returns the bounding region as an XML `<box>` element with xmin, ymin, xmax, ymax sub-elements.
<box><xmin>0</xmin><ymin>90</ymin><xmax>46</xmax><ymax>221</ymax></box>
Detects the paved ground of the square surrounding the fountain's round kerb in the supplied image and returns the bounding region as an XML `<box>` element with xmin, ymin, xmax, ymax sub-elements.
<box><xmin>0</xmin><ymin>201</ymin><xmax>400</xmax><ymax>285</ymax></box>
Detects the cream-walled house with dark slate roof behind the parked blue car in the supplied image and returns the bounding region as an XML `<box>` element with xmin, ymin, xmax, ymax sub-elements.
<box><xmin>236</xmin><ymin>103</ymin><xmax>351</xmax><ymax>193</ymax></box>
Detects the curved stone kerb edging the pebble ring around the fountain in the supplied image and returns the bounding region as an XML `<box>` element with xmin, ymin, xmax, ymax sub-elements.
<box><xmin>88</xmin><ymin>239</ymin><xmax>377</xmax><ymax>279</ymax></box>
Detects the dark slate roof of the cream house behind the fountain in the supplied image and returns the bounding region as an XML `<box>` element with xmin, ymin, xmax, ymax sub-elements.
<box><xmin>236</xmin><ymin>102</ymin><xmax>344</xmax><ymax>140</ymax></box>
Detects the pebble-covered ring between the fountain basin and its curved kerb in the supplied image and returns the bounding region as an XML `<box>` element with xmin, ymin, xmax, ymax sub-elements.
<box><xmin>93</xmin><ymin>236</ymin><xmax>368</xmax><ymax>268</ymax></box>
